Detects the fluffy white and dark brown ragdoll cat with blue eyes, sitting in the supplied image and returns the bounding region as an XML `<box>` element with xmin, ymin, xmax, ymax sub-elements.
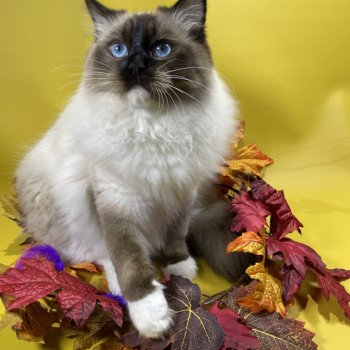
<box><xmin>16</xmin><ymin>0</ymin><xmax>252</xmax><ymax>337</ymax></box>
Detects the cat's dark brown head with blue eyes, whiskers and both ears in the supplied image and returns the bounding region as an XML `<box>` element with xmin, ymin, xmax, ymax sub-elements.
<box><xmin>84</xmin><ymin>0</ymin><xmax>212</xmax><ymax>104</ymax></box>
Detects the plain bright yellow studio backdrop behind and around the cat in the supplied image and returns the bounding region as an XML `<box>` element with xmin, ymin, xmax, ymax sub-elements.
<box><xmin>0</xmin><ymin>0</ymin><xmax>350</xmax><ymax>350</ymax></box>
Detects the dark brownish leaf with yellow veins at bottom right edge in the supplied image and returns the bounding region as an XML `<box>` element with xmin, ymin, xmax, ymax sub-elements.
<box><xmin>225</xmin><ymin>293</ymin><xmax>317</xmax><ymax>350</ymax></box>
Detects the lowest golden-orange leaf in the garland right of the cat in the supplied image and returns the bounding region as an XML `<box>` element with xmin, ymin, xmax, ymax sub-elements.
<box><xmin>239</xmin><ymin>263</ymin><xmax>286</xmax><ymax>317</ymax></box>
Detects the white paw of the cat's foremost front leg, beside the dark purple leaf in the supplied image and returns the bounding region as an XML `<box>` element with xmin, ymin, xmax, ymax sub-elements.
<box><xmin>128</xmin><ymin>281</ymin><xmax>172</xmax><ymax>338</ymax></box>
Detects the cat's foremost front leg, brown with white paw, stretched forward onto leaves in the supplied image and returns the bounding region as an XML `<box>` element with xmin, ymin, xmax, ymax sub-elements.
<box><xmin>96</xmin><ymin>191</ymin><xmax>172</xmax><ymax>338</ymax></box>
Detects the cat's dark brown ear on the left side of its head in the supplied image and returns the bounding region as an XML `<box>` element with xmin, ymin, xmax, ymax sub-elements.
<box><xmin>85</xmin><ymin>0</ymin><xmax>125</xmax><ymax>36</ymax></box>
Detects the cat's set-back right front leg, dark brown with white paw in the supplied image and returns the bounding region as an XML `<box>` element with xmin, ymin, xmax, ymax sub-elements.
<box><xmin>161</xmin><ymin>207</ymin><xmax>197</xmax><ymax>281</ymax></box>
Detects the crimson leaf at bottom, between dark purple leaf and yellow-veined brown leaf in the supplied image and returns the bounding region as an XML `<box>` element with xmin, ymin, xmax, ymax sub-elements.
<box><xmin>209</xmin><ymin>303</ymin><xmax>260</xmax><ymax>350</ymax></box>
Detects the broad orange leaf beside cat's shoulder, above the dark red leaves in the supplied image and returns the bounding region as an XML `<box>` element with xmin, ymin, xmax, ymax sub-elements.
<box><xmin>226</xmin><ymin>144</ymin><xmax>273</xmax><ymax>177</ymax></box>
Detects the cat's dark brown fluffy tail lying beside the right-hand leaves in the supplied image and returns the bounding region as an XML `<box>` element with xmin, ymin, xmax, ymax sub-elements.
<box><xmin>188</xmin><ymin>189</ymin><xmax>256</xmax><ymax>281</ymax></box>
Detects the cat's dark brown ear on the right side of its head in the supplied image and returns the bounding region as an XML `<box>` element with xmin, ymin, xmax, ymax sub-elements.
<box><xmin>171</xmin><ymin>0</ymin><xmax>207</xmax><ymax>40</ymax></box>
